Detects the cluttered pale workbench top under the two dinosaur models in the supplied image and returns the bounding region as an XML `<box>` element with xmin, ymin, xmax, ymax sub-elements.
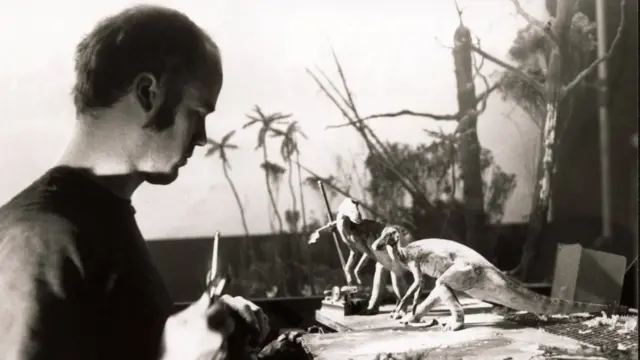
<box><xmin>303</xmin><ymin>296</ymin><xmax>600</xmax><ymax>360</ymax></box>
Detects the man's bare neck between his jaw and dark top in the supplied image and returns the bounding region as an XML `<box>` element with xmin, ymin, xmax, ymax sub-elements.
<box><xmin>58</xmin><ymin>124</ymin><xmax>143</xmax><ymax>199</ymax></box>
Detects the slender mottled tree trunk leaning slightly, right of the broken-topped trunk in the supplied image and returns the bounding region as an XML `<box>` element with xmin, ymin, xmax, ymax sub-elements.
<box><xmin>509</xmin><ymin>0</ymin><xmax>578</xmax><ymax>281</ymax></box>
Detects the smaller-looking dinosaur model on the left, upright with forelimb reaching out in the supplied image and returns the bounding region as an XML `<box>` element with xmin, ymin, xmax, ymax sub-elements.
<box><xmin>309</xmin><ymin>198</ymin><xmax>414</xmax><ymax>318</ymax></box>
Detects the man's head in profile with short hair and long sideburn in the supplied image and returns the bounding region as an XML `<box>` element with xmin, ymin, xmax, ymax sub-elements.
<box><xmin>73</xmin><ymin>5</ymin><xmax>222</xmax><ymax>184</ymax></box>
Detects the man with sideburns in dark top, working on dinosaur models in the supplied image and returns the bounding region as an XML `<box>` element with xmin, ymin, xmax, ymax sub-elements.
<box><xmin>0</xmin><ymin>6</ymin><xmax>268</xmax><ymax>360</ymax></box>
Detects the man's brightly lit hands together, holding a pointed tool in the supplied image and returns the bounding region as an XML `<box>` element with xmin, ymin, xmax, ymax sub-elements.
<box><xmin>162</xmin><ymin>293</ymin><xmax>269</xmax><ymax>360</ymax></box>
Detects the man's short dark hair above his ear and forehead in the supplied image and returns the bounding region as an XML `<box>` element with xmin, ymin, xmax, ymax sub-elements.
<box><xmin>73</xmin><ymin>5</ymin><xmax>222</xmax><ymax>113</ymax></box>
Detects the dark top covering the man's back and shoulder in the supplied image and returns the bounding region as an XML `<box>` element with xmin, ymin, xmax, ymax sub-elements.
<box><xmin>0</xmin><ymin>167</ymin><xmax>172</xmax><ymax>360</ymax></box>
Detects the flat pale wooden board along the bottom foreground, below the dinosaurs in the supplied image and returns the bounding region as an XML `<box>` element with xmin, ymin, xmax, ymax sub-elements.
<box><xmin>303</xmin><ymin>324</ymin><xmax>592</xmax><ymax>360</ymax></box>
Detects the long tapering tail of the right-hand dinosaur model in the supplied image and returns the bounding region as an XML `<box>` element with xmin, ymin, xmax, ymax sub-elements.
<box><xmin>480</xmin><ymin>269</ymin><xmax>610</xmax><ymax>315</ymax></box>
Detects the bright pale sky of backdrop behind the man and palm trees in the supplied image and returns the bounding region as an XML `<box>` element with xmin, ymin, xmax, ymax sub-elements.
<box><xmin>0</xmin><ymin>0</ymin><xmax>546</xmax><ymax>239</ymax></box>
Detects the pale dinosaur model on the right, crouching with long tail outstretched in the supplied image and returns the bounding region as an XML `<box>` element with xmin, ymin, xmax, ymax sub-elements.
<box><xmin>372</xmin><ymin>225</ymin><xmax>611</xmax><ymax>331</ymax></box>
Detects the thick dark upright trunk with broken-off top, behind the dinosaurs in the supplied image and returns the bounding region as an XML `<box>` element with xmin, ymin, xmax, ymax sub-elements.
<box><xmin>453</xmin><ymin>25</ymin><xmax>493</xmax><ymax>258</ymax></box>
